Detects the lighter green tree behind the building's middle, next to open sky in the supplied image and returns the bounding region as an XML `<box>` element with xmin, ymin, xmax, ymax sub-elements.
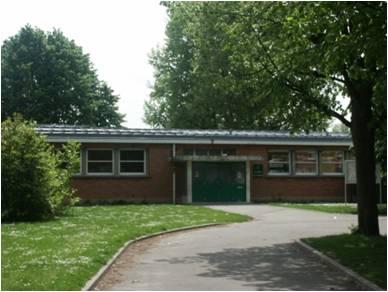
<box><xmin>145</xmin><ymin>3</ymin><xmax>328</xmax><ymax>130</ymax></box>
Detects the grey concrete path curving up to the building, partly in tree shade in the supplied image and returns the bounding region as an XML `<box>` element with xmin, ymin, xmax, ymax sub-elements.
<box><xmin>95</xmin><ymin>205</ymin><xmax>386</xmax><ymax>290</ymax></box>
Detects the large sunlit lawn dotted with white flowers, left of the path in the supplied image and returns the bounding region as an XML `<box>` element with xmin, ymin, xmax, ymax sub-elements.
<box><xmin>1</xmin><ymin>205</ymin><xmax>249</xmax><ymax>290</ymax></box>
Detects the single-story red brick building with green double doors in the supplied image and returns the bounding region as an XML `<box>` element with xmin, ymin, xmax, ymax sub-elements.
<box><xmin>37</xmin><ymin>125</ymin><xmax>354</xmax><ymax>203</ymax></box>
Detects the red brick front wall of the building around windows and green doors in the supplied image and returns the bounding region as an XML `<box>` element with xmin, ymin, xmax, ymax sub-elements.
<box><xmin>65</xmin><ymin>144</ymin><xmax>346</xmax><ymax>203</ymax></box>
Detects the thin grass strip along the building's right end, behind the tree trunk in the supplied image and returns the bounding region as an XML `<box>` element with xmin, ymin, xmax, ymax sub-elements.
<box><xmin>271</xmin><ymin>203</ymin><xmax>387</xmax><ymax>216</ymax></box>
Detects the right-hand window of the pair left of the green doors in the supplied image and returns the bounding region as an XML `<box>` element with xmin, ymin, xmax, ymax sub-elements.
<box><xmin>120</xmin><ymin>149</ymin><xmax>146</xmax><ymax>174</ymax></box>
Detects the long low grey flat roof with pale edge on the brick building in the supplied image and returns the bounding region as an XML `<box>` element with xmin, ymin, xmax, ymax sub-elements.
<box><xmin>36</xmin><ymin>124</ymin><xmax>352</xmax><ymax>146</ymax></box>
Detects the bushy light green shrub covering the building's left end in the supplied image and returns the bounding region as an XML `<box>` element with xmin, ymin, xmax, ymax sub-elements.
<box><xmin>1</xmin><ymin>115</ymin><xmax>79</xmax><ymax>221</ymax></box>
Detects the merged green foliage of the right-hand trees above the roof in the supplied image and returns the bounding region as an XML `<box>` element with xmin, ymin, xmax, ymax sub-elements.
<box><xmin>145</xmin><ymin>2</ymin><xmax>386</xmax><ymax>133</ymax></box>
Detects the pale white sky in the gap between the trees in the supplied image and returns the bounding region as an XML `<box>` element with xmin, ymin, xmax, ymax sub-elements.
<box><xmin>0</xmin><ymin>0</ymin><xmax>167</xmax><ymax>128</ymax></box>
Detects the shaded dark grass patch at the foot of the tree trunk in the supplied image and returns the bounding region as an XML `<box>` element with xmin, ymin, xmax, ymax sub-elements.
<box><xmin>303</xmin><ymin>234</ymin><xmax>387</xmax><ymax>289</ymax></box>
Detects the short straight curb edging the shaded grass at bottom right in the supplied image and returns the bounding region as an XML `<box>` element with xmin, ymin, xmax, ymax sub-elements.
<box><xmin>295</xmin><ymin>240</ymin><xmax>384</xmax><ymax>291</ymax></box>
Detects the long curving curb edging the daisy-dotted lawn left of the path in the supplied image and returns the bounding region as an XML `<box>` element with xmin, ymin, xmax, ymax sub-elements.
<box><xmin>81</xmin><ymin>223</ymin><xmax>224</xmax><ymax>291</ymax></box>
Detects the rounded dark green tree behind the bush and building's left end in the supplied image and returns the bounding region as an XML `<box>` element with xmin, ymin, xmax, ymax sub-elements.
<box><xmin>1</xmin><ymin>25</ymin><xmax>123</xmax><ymax>126</ymax></box>
